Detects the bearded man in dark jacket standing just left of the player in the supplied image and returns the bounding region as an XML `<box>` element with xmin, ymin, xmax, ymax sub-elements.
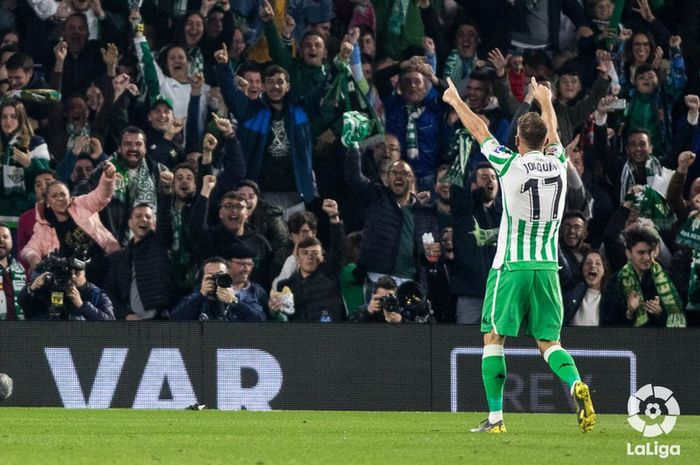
<box><xmin>449</xmin><ymin>162</ymin><xmax>503</xmax><ymax>324</ymax></box>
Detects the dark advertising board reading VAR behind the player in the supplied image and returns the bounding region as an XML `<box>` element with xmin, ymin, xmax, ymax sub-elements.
<box><xmin>0</xmin><ymin>322</ymin><xmax>700</xmax><ymax>414</ymax></box>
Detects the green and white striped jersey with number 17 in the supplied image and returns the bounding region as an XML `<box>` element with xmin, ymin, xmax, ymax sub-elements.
<box><xmin>481</xmin><ymin>138</ymin><xmax>566</xmax><ymax>270</ymax></box>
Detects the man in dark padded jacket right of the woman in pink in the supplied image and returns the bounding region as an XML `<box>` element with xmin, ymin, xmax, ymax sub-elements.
<box><xmin>104</xmin><ymin>204</ymin><xmax>172</xmax><ymax>321</ymax></box>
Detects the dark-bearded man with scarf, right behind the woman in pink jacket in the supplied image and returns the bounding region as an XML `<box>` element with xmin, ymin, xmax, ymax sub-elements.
<box><xmin>76</xmin><ymin>126</ymin><xmax>160</xmax><ymax>245</ymax></box>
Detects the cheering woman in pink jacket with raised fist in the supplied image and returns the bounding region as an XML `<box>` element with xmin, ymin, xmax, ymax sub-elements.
<box><xmin>21</xmin><ymin>162</ymin><xmax>119</xmax><ymax>282</ymax></box>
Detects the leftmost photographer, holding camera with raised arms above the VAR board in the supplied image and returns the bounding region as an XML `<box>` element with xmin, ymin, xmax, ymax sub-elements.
<box><xmin>18</xmin><ymin>255</ymin><xmax>114</xmax><ymax>321</ymax></box>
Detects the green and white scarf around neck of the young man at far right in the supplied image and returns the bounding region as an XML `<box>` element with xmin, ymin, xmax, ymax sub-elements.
<box><xmin>617</xmin><ymin>261</ymin><xmax>685</xmax><ymax>328</ymax></box>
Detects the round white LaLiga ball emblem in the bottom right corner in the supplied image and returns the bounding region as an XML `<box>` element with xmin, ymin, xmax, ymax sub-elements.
<box><xmin>627</xmin><ymin>384</ymin><xmax>681</xmax><ymax>438</ymax></box>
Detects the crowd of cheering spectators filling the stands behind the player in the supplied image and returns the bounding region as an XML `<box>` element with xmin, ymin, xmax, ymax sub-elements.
<box><xmin>0</xmin><ymin>0</ymin><xmax>700</xmax><ymax>327</ymax></box>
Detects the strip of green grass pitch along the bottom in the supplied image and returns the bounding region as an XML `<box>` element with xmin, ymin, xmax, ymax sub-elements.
<box><xmin>0</xmin><ymin>408</ymin><xmax>700</xmax><ymax>465</ymax></box>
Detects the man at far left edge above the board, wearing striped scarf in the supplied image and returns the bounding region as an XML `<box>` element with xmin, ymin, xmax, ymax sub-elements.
<box><xmin>0</xmin><ymin>223</ymin><xmax>27</xmax><ymax>320</ymax></box>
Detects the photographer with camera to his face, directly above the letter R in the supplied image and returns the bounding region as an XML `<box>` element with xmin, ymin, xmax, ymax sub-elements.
<box><xmin>170</xmin><ymin>257</ymin><xmax>265</xmax><ymax>321</ymax></box>
